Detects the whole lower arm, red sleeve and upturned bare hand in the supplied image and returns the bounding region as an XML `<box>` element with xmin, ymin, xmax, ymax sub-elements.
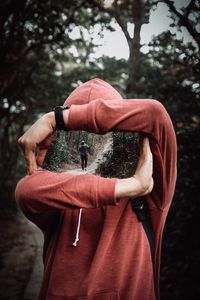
<box><xmin>15</xmin><ymin>138</ymin><xmax>153</xmax><ymax>228</ymax></box>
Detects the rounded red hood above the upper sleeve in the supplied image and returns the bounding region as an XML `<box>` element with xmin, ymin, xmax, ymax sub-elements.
<box><xmin>64</xmin><ymin>78</ymin><xmax>122</xmax><ymax>107</ymax></box>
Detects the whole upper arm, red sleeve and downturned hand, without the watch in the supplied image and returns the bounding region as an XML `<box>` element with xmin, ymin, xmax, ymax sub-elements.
<box><xmin>19</xmin><ymin>99</ymin><xmax>177</xmax><ymax>209</ymax></box>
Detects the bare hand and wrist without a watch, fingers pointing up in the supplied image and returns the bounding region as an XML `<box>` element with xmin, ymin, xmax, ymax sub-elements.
<box><xmin>115</xmin><ymin>138</ymin><xmax>153</xmax><ymax>198</ymax></box>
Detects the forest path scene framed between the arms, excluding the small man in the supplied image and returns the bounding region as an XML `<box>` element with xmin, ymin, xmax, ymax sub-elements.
<box><xmin>43</xmin><ymin>131</ymin><xmax>139</xmax><ymax>178</ymax></box>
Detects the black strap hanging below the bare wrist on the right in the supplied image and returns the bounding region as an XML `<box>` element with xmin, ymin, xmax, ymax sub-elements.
<box><xmin>130</xmin><ymin>197</ymin><xmax>155</xmax><ymax>279</ymax></box>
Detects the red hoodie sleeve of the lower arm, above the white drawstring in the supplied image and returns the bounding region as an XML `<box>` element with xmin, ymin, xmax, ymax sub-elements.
<box><xmin>15</xmin><ymin>170</ymin><xmax>117</xmax><ymax>223</ymax></box>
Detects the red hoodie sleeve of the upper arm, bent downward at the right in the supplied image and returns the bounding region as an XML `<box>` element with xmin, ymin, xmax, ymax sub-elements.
<box><xmin>68</xmin><ymin>99</ymin><xmax>177</xmax><ymax>209</ymax></box>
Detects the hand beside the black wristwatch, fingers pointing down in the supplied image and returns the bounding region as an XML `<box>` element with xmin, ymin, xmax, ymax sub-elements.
<box><xmin>18</xmin><ymin>112</ymin><xmax>56</xmax><ymax>175</ymax></box>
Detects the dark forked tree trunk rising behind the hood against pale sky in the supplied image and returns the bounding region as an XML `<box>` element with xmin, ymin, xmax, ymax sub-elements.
<box><xmin>90</xmin><ymin>0</ymin><xmax>158</xmax><ymax>98</ymax></box>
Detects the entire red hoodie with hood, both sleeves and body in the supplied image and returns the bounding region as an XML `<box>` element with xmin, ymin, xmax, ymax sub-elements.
<box><xmin>16</xmin><ymin>79</ymin><xmax>176</xmax><ymax>300</ymax></box>
